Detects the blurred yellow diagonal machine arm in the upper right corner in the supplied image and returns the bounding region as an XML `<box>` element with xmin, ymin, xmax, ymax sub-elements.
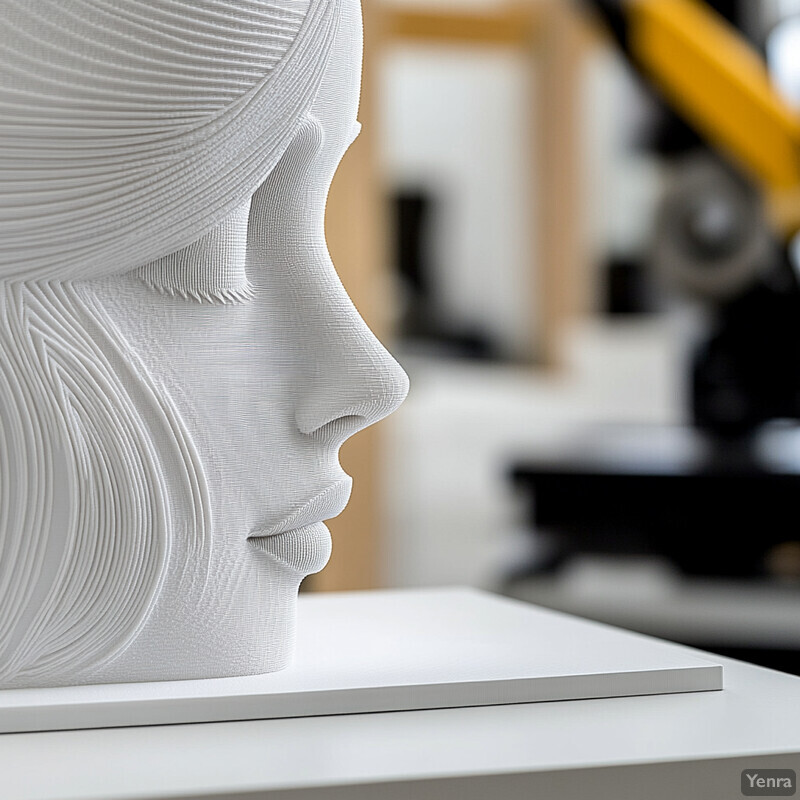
<box><xmin>594</xmin><ymin>0</ymin><xmax>800</xmax><ymax>238</ymax></box>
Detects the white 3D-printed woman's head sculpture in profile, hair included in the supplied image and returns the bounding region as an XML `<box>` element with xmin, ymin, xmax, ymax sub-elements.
<box><xmin>0</xmin><ymin>0</ymin><xmax>407</xmax><ymax>688</ymax></box>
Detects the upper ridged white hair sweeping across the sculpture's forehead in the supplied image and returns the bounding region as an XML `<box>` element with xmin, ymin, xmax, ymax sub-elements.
<box><xmin>0</xmin><ymin>0</ymin><xmax>337</xmax><ymax>280</ymax></box>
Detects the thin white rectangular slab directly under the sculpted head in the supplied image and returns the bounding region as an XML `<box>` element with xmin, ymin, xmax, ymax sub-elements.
<box><xmin>0</xmin><ymin>589</ymin><xmax>722</xmax><ymax>733</ymax></box>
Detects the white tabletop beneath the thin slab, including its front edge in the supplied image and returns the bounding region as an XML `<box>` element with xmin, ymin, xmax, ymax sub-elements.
<box><xmin>0</xmin><ymin>592</ymin><xmax>800</xmax><ymax>800</ymax></box>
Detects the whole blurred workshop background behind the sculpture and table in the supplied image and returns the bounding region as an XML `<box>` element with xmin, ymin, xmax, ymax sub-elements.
<box><xmin>316</xmin><ymin>0</ymin><xmax>800</xmax><ymax>674</ymax></box>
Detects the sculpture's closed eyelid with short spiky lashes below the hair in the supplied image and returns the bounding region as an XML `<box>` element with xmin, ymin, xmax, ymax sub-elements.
<box><xmin>137</xmin><ymin>199</ymin><xmax>253</xmax><ymax>303</ymax></box>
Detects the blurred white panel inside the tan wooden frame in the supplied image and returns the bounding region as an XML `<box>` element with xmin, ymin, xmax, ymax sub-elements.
<box><xmin>381</xmin><ymin>46</ymin><xmax>536</xmax><ymax>357</ymax></box>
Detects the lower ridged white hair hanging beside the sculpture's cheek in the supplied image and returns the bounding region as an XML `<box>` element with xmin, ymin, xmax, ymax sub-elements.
<box><xmin>0</xmin><ymin>282</ymin><xmax>209</xmax><ymax>686</ymax></box>
